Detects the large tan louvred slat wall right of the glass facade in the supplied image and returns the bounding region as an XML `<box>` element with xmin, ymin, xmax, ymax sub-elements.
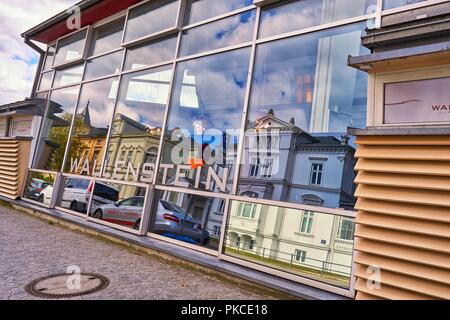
<box><xmin>355</xmin><ymin>136</ymin><xmax>450</xmax><ymax>299</ymax></box>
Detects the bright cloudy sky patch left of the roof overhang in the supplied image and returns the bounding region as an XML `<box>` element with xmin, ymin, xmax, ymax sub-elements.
<box><xmin>0</xmin><ymin>0</ymin><xmax>78</xmax><ymax>104</ymax></box>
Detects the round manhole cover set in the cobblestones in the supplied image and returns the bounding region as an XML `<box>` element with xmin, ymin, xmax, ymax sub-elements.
<box><xmin>25</xmin><ymin>273</ymin><xmax>109</xmax><ymax>299</ymax></box>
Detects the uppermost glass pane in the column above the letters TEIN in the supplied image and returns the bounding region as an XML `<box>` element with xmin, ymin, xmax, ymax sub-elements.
<box><xmin>185</xmin><ymin>0</ymin><xmax>253</xmax><ymax>24</ymax></box>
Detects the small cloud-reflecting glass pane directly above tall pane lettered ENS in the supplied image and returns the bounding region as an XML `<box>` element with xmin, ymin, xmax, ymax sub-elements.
<box><xmin>124</xmin><ymin>36</ymin><xmax>177</xmax><ymax>70</ymax></box>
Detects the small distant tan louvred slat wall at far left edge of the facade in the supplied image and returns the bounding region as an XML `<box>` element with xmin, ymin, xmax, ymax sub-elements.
<box><xmin>0</xmin><ymin>139</ymin><xmax>31</xmax><ymax>199</ymax></box>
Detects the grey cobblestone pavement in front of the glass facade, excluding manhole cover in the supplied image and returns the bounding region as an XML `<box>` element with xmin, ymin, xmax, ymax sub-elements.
<box><xmin>0</xmin><ymin>206</ymin><xmax>265</xmax><ymax>300</ymax></box>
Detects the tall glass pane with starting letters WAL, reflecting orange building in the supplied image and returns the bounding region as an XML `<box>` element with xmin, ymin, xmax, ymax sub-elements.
<box><xmin>64</xmin><ymin>77</ymin><xmax>118</xmax><ymax>176</ymax></box>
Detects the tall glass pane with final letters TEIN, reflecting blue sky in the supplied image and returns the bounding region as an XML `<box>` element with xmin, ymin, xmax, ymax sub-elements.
<box><xmin>159</xmin><ymin>48</ymin><xmax>250</xmax><ymax>192</ymax></box>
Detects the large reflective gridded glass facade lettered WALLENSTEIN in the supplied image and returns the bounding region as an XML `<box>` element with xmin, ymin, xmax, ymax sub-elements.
<box><xmin>23</xmin><ymin>0</ymin><xmax>442</xmax><ymax>295</ymax></box>
